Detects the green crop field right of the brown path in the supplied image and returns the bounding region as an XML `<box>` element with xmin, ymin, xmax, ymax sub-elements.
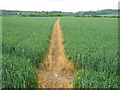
<box><xmin>61</xmin><ymin>18</ymin><xmax>118</xmax><ymax>88</ymax></box>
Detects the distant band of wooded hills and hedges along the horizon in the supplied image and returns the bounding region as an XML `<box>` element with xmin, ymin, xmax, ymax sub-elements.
<box><xmin>2</xmin><ymin>9</ymin><xmax>120</xmax><ymax>17</ymax></box>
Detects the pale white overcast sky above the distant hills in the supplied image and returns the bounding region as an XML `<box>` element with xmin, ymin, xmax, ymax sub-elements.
<box><xmin>0</xmin><ymin>0</ymin><xmax>120</xmax><ymax>12</ymax></box>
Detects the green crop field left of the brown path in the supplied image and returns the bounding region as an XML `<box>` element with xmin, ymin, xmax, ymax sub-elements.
<box><xmin>2</xmin><ymin>17</ymin><xmax>56</xmax><ymax>88</ymax></box>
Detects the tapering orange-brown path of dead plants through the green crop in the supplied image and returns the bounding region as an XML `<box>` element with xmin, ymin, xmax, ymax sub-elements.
<box><xmin>38</xmin><ymin>18</ymin><xmax>74</xmax><ymax>88</ymax></box>
